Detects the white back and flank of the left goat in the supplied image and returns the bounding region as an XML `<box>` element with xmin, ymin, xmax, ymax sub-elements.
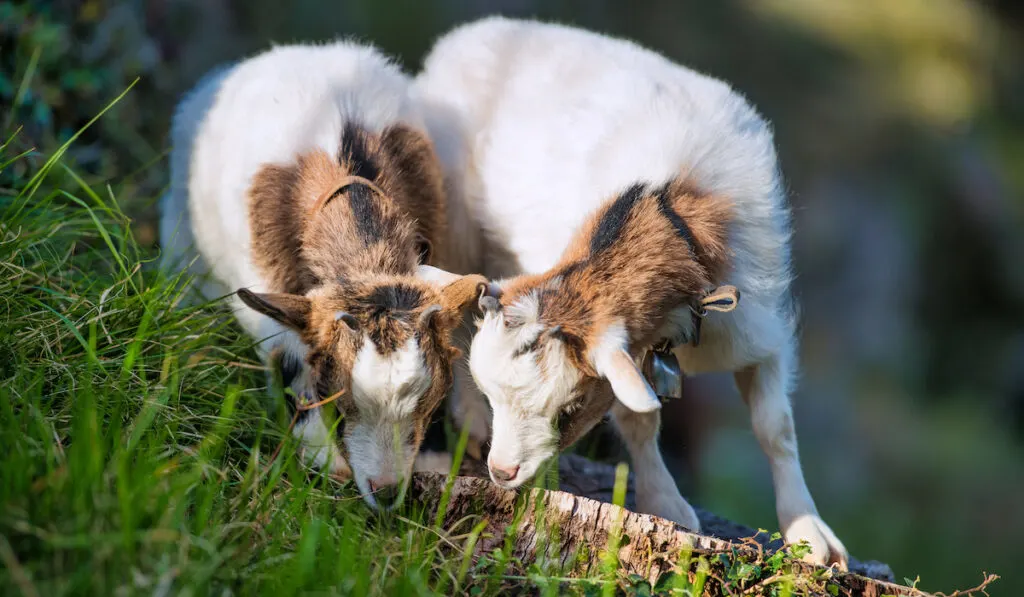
<box><xmin>162</xmin><ymin>42</ymin><xmax>424</xmax><ymax>334</ymax></box>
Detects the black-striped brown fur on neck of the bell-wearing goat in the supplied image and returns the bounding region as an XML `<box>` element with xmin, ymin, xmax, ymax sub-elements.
<box><xmin>501</xmin><ymin>176</ymin><xmax>732</xmax><ymax>354</ymax></box>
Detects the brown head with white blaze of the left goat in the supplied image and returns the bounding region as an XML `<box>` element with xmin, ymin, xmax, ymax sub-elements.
<box><xmin>239</xmin><ymin>265</ymin><xmax>485</xmax><ymax>508</ymax></box>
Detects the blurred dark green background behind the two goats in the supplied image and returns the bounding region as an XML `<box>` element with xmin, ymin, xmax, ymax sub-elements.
<box><xmin>0</xmin><ymin>0</ymin><xmax>1024</xmax><ymax>596</ymax></box>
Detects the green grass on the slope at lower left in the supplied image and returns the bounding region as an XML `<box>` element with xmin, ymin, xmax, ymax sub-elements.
<box><xmin>0</xmin><ymin>116</ymin><xmax>872</xmax><ymax>597</ymax></box>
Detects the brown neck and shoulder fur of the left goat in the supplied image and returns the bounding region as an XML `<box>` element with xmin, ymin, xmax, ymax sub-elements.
<box><xmin>249</xmin><ymin>124</ymin><xmax>445</xmax><ymax>294</ymax></box>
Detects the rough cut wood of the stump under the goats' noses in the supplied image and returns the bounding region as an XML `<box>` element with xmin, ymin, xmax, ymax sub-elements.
<box><xmin>411</xmin><ymin>455</ymin><xmax>927</xmax><ymax>597</ymax></box>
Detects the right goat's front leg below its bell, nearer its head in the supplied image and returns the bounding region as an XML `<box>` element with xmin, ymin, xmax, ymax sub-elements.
<box><xmin>611</xmin><ymin>400</ymin><xmax>700</xmax><ymax>531</ymax></box>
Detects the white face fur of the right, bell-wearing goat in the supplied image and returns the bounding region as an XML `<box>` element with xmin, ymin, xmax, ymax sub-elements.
<box><xmin>469</xmin><ymin>295</ymin><xmax>582</xmax><ymax>487</ymax></box>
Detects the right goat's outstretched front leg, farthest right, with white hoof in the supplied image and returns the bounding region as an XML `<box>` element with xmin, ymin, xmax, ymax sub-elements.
<box><xmin>735</xmin><ymin>352</ymin><xmax>849</xmax><ymax>570</ymax></box>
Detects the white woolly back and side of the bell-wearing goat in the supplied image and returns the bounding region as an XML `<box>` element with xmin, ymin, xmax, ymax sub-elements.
<box><xmin>417</xmin><ymin>17</ymin><xmax>790</xmax><ymax>309</ymax></box>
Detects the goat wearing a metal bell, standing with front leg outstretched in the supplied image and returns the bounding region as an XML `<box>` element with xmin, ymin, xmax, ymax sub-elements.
<box><xmin>416</xmin><ymin>17</ymin><xmax>847</xmax><ymax>566</ymax></box>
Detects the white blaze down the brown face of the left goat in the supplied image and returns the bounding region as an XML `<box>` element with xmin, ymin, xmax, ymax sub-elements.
<box><xmin>345</xmin><ymin>337</ymin><xmax>431</xmax><ymax>507</ymax></box>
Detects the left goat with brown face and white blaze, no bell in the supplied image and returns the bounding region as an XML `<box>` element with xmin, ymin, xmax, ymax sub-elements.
<box><xmin>161</xmin><ymin>42</ymin><xmax>485</xmax><ymax>507</ymax></box>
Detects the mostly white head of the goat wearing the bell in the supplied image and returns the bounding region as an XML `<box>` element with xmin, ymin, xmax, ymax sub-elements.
<box><xmin>469</xmin><ymin>276</ymin><xmax>738</xmax><ymax>487</ymax></box>
